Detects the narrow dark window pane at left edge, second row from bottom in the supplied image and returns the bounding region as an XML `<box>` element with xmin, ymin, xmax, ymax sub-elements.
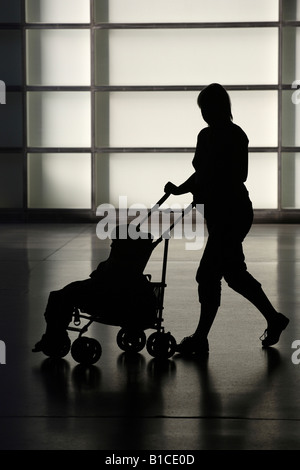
<box><xmin>0</xmin><ymin>92</ymin><xmax>23</xmax><ymax>147</ymax></box>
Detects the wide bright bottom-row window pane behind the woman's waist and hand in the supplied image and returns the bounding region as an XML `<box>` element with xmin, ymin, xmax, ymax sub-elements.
<box><xmin>96</xmin><ymin>153</ymin><xmax>277</xmax><ymax>209</ymax></box>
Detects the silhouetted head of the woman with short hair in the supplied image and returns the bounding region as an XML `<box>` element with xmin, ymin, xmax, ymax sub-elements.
<box><xmin>197</xmin><ymin>83</ymin><xmax>232</xmax><ymax>126</ymax></box>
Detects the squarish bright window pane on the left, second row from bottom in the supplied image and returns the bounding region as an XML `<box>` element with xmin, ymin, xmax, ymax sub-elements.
<box><xmin>28</xmin><ymin>92</ymin><xmax>91</xmax><ymax>147</ymax></box>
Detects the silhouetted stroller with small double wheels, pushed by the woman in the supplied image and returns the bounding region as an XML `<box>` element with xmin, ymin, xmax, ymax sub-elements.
<box><xmin>44</xmin><ymin>194</ymin><xmax>189</xmax><ymax>364</ymax></box>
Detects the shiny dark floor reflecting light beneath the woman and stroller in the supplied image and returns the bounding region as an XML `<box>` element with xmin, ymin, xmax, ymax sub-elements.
<box><xmin>0</xmin><ymin>224</ymin><xmax>300</xmax><ymax>451</ymax></box>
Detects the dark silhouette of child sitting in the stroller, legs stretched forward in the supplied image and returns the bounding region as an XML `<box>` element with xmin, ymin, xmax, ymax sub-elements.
<box><xmin>33</xmin><ymin>226</ymin><xmax>160</xmax><ymax>356</ymax></box>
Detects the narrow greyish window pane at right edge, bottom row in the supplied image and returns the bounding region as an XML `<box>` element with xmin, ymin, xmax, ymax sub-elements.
<box><xmin>282</xmin><ymin>153</ymin><xmax>300</xmax><ymax>209</ymax></box>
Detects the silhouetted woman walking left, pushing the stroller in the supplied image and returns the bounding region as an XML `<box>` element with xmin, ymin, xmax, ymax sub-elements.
<box><xmin>165</xmin><ymin>83</ymin><xmax>289</xmax><ymax>354</ymax></box>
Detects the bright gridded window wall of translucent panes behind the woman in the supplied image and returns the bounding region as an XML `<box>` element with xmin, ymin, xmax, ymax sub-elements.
<box><xmin>0</xmin><ymin>0</ymin><xmax>300</xmax><ymax>217</ymax></box>
